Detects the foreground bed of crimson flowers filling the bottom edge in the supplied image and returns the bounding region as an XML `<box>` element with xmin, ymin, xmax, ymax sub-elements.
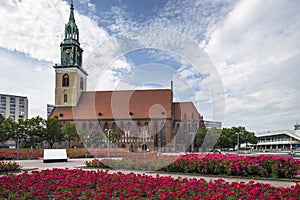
<box><xmin>0</xmin><ymin>169</ymin><xmax>300</xmax><ymax>200</ymax></box>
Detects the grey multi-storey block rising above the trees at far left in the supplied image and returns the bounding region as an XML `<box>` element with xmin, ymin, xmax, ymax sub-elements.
<box><xmin>0</xmin><ymin>94</ymin><xmax>28</xmax><ymax>121</ymax></box>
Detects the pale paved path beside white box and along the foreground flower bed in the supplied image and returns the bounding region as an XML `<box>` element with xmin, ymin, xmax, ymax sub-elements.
<box><xmin>11</xmin><ymin>158</ymin><xmax>295</xmax><ymax>187</ymax></box>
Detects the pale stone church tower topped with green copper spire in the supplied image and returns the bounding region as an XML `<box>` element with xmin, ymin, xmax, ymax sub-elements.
<box><xmin>54</xmin><ymin>3</ymin><xmax>88</xmax><ymax>106</ymax></box>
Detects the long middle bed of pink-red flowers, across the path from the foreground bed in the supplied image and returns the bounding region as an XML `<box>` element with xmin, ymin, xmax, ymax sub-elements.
<box><xmin>85</xmin><ymin>154</ymin><xmax>300</xmax><ymax>178</ymax></box>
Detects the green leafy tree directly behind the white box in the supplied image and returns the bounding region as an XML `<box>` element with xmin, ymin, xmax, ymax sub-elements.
<box><xmin>44</xmin><ymin>116</ymin><xmax>64</xmax><ymax>149</ymax></box>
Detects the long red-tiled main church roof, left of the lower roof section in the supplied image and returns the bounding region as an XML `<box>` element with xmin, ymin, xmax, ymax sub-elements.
<box><xmin>49</xmin><ymin>89</ymin><xmax>172</xmax><ymax>120</ymax></box>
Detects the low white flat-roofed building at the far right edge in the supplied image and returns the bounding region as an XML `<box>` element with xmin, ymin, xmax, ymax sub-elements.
<box><xmin>256</xmin><ymin>125</ymin><xmax>300</xmax><ymax>150</ymax></box>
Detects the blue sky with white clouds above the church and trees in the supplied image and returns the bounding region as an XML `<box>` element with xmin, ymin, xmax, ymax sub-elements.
<box><xmin>0</xmin><ymin>0</ymin><xmax>300</xmax><ymax>133</ymax></box>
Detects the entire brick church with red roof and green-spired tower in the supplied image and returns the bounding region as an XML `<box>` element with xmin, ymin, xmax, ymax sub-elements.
<box><xmin>49</xmin><ymin>4</ymin><xmax>204</xmax><ymax>152</ymax></box>
